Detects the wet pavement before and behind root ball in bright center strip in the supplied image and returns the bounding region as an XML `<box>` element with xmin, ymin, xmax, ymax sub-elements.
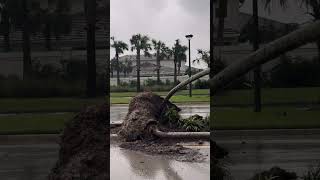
<box><xmin>110</xmin><ymin>105</ymin><xmax>210</xmax><ymax>180</ymax></box>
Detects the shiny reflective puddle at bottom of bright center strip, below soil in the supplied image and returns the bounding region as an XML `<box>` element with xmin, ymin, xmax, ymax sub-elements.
<box><xmin>110</xmin><ymin>145</ymin><xmax>210</xmax><ymax>180</ymax></box>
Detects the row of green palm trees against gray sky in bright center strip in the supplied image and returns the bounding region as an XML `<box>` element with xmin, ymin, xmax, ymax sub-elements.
<box><xmin>111</xmin><ymin>34</ymin><xmax>188</xmax><ymax>92</ymax></box>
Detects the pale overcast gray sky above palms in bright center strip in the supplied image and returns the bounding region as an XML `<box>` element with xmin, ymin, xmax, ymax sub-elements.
<box><xmin>110</xmin><ymin>0</ymin><xmax>210</xmax><ymax>68</ymax></box>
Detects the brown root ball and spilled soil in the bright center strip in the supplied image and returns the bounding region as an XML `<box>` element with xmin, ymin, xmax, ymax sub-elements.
<box><xmin>116</xmin><ymin>92</ymin><xmax>206</xmax><ymax>162</ymax></box>
